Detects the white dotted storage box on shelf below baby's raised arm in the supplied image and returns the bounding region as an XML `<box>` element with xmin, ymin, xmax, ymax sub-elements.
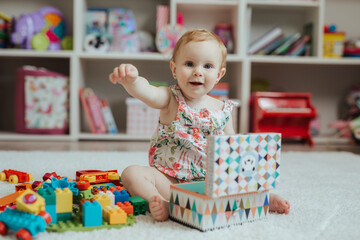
<box><xmin>126</xmin><ymin>98</ymin><xmax>160</xmax><ymax>136</ymax></box>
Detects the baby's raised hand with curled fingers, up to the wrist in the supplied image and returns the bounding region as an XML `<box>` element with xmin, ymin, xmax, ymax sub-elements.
<box><xmin>109</xmin><ymin>64</ymin><xmax>139</xmax><ymax>84</ymax></box>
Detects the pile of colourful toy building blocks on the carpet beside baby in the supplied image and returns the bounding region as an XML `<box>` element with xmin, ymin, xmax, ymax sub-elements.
<box><xmin>0</xmin><ymin>169</ymin><xmax>146</xmax><ymax>239</ymax></box>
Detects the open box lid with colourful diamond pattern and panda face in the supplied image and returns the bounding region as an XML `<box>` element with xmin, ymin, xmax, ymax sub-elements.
<box><xmin>205</xmin><ymin>133</ymin><xmax>281</xmax><ymax>197</ymax></box>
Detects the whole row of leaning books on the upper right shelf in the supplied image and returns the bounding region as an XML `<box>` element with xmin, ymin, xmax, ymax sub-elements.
<box><xmin>248</xmin><ymin>27</ymin><xmax>311</xmax><ymax>56</ymax></box>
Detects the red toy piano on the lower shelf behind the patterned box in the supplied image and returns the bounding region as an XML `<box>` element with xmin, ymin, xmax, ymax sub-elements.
<box><xmin>251</xmin><ymin>92</ymin><xmax>316</xmax><ymax>146</ymax></box>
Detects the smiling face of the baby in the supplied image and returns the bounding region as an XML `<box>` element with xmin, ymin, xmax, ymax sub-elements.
<box><xmin>170</xmin><ymin>40</ymin><xmax>225</xmax><ymax>99</ymax></box>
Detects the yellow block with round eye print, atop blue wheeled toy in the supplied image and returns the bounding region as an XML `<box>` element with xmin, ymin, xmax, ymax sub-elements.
<box><xmin>16</xmin><ymin>189</ymin><xmax>45</xmax><ymax>215</ymax></box>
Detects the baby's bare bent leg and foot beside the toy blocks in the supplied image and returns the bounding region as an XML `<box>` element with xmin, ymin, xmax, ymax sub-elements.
<box><xmin>121</xmin><ymin>165</ymin><xmax>177</xmax><ymax>221</ymax></box>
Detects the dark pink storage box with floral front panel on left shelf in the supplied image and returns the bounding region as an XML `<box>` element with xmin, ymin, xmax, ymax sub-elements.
<box><xmin>15</xmin><ymin>66</ymin><xmax>69</xmax><ymax>134</ymax></box>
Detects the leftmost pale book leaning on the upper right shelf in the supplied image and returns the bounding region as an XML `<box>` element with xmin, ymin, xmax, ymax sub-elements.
<box><xmin>248</xmin><ymin>27</ymin><xmax>283</xmax><ymax>54</ymax></box>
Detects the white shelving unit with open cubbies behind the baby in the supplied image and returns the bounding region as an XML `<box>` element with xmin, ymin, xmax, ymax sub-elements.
<box><xmin>0</xmin><ymin>0</ymin><xmax>360</xmax><ymax>142</ymax></box>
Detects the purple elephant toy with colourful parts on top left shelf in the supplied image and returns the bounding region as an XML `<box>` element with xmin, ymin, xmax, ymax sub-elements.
<box><xmin>11</xmin><ymin>7</ymin><xmax>66</xmax><ymax>50</ymax></box>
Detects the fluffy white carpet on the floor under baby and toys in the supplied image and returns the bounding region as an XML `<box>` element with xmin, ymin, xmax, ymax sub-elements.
<box><xmin>0</xmin><ymin>151</ymin><xmax>360</xmax><ymax>240</ymax></box>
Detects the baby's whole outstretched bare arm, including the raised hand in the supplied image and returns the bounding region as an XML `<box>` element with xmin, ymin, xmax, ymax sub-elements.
<box><xmin>109</xmin><ymin>64</ymin><xmax>171</xmax><ymax>109</ymax></box>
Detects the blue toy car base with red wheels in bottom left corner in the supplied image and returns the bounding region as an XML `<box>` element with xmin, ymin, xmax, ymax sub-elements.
<box><xmin>0</xmin><ymin>208</ymin><xmax>51</xmax><ymax>240</ymax></box>
